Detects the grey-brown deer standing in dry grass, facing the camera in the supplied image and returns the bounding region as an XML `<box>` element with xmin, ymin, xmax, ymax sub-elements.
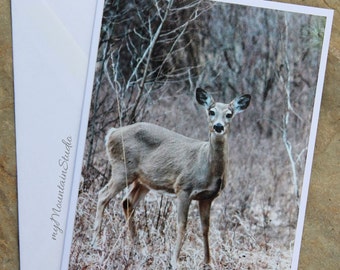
<box><xmin>92</xmin><ymin>88</ymin><xmax>250</xmax><ymax>263</ymax></box>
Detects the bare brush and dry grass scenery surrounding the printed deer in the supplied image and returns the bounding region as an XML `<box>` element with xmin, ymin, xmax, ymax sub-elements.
<box><xmin>70</xmin><ymin>1</ymin><xmax>325</xmax><ymax>269</ymax></box>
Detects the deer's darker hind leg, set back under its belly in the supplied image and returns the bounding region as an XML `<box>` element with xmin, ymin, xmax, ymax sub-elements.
<box><xmin>122</xmin><ymin>181</ymin><xmax>149</xmax><ymax>243</ymax></box>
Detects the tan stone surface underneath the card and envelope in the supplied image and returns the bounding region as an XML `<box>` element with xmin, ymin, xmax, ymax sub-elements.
<box><xmin>0</xmin><ymin>0</ymin><xmax>340</xmax><ymax>270</ymax></box>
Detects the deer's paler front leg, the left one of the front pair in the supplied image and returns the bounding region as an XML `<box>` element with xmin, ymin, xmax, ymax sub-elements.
<box><xmin>173</xmin><ymin>192</ymin><xmax>191</xmax><ymax>264</ymax></box>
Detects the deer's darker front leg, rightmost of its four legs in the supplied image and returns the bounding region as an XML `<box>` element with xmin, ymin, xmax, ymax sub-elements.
<box><xmin>199</xmin><ymin>200</ymin><xmax>212</xmax><ymax>264</ymax></box>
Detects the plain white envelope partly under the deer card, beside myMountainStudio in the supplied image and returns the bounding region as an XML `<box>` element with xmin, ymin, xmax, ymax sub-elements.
<box><xmin>12</xmin><ymin>0</ymin><xmax>97</xmax><ymax>270</ymax></box>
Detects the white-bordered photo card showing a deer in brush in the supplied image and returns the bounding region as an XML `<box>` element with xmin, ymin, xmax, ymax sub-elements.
<box><xmin>62</xmin><ymin>0</ymin><xmax>333</xmax><ymax>269</ymax></box>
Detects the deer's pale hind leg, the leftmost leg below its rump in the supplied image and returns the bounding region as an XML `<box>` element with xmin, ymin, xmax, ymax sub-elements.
<box><xmin>92</xmin><ymin>170</ymin><xmax>133</xmax><ymax>246</ymax></box>
